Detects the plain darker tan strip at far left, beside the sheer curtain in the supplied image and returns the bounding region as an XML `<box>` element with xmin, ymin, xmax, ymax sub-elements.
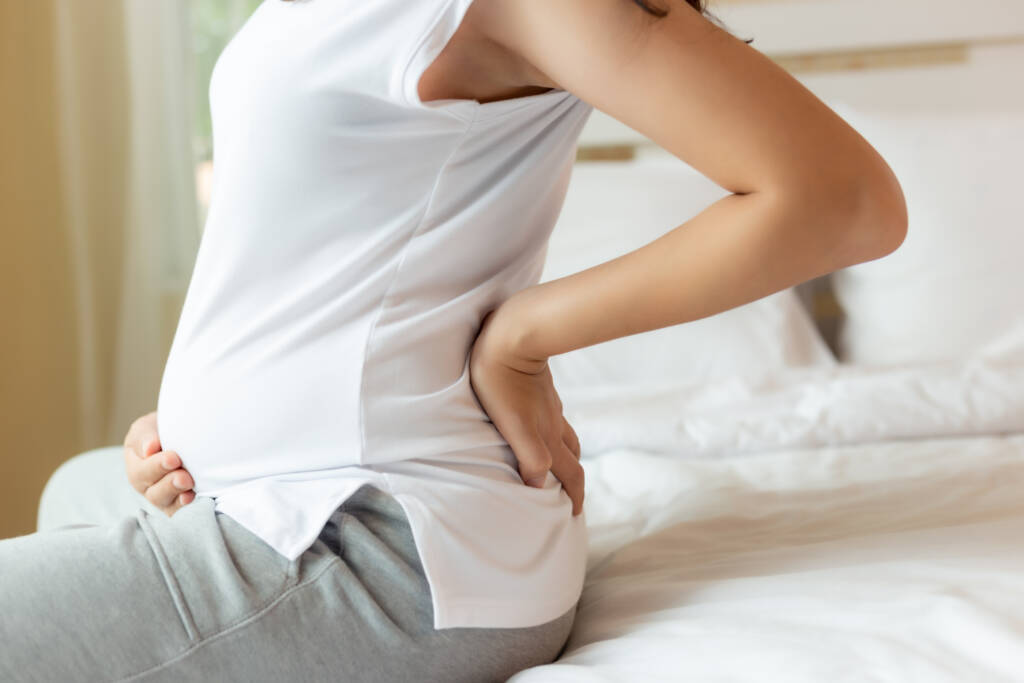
<box><xmin>0</xmin><ymin>0</ymin><xmax>81</xmax><ymax>537</ymax></box>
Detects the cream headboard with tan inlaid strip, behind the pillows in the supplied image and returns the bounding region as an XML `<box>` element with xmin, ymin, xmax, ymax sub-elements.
<box><xmin>577</xmin><ymin>0</ymin><xmax>1024</xmax><ymax>358</ymax></box>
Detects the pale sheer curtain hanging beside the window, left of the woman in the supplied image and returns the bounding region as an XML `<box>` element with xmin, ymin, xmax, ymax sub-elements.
<box><xmin>56</xmin><ymin>0</ymin><xmax>200</xmax><ymax>455</ymax></box>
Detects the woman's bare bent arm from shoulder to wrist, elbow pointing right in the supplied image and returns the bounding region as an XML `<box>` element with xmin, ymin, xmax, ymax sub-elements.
<box><xmin>477</xmin><ymin>0</ymin><xmax>907</xmax><ymax>371</ymax></box>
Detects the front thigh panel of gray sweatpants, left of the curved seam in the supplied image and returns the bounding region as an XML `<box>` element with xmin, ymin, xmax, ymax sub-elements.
<box><xmin>0</xmin><ymin>499</ymin><xmax>295</xmax><ymax>681</ymax></box>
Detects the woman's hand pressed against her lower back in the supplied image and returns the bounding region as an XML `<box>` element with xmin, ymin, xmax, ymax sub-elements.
<box><xmin>469</xmin><ymin>307</ymin><xmax>584</xmax><ymax>515</ymax></box>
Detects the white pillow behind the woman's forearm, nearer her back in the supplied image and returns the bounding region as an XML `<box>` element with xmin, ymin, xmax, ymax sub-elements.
<box><xmin>541</xmin><ymin>157</ymin><xmax>836</xmax><ymax>391</ymax></box>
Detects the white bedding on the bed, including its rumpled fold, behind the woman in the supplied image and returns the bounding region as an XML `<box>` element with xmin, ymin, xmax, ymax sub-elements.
<box><xmin>511</xmin><ymin>356</ymin><xmax>1024</xmax><ymax>683</ymax></box>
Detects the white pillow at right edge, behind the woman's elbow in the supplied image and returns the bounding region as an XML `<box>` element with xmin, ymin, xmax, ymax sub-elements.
<box><xmin>831</xmin><ymin>102</ymin><xmax>1024</xmax><ymax>365</ymax></box>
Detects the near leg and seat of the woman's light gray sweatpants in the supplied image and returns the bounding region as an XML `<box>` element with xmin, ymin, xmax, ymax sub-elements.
<box><xmin>0</xmin><ymin>484</ymin><xmax>575</xmax><ymax>683</ymax></box>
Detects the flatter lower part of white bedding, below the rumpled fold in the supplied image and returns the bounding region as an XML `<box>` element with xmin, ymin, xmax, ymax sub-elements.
<box><xmin>511</xmin><ymin>434</ymin><xmax>1024</xmax><ymax>683</ymax></box>
